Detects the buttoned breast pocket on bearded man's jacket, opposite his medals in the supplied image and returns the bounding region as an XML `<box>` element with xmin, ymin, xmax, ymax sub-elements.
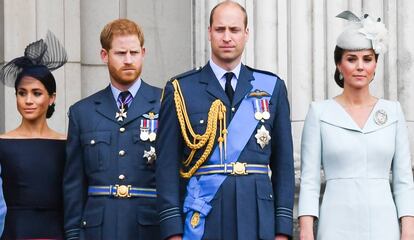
<box><xmin>81</xmin><ymin>131</ymin><xmax>111</xmax><ymax>173</ymax></box>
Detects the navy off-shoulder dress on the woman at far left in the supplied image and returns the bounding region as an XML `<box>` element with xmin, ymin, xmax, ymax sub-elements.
<box><xmin>0</xmin><ymin>139</ymin><xmax>66</xmax><ymax>239</ymax></box>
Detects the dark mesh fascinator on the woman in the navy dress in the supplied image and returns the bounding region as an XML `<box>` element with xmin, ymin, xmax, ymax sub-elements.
<box><xmin>0</xmin><ymin>31</ymin><xmax>68</xmax><ymax>87</ymax></box>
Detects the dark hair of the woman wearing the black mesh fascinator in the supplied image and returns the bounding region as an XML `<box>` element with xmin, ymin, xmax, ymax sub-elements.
<box><xmin>14</xmin><ymin>66</ymin><xmax>56</xmax><ymax>118</ymax></box>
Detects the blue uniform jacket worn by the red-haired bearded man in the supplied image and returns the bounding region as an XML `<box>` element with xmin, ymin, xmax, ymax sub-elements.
<box><xmin>64</xmin><ymin>81</ymin><xmax>161</xmax><ymax>240</ymax></box>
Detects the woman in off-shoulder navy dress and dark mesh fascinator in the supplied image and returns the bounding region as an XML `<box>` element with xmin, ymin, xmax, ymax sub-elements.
<box><xmin>0</xmin><ymin>32</ymin><xmax>67</xmax><ymax>239</ymax></box>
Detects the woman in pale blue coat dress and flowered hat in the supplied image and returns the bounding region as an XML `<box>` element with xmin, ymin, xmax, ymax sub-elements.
<box><xmin>299</xmin><ymin>11</ymin><xmax>414</xmax><ymax>240</ymax></box>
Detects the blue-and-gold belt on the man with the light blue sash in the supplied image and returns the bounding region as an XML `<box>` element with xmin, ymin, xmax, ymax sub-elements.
<box><xmin>194</xmin><ymin>162</ymin><xmax>269</xmax><ymax>176</ymax></box>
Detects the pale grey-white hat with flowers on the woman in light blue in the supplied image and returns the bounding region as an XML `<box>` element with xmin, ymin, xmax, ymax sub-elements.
<box><xmin>336</xmin><ymin>11</ymin><xmax>388</xmax><ymax>54</ymax></box>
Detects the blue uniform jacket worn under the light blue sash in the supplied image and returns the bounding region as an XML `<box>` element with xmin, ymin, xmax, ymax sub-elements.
<box><xmin>156</xmin><ymin>64</ymin><xmax>294</xmax><ymax>240</ymax></box>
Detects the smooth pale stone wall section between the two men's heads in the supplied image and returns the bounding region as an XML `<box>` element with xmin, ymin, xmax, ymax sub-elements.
<box><xmin>126</xmin><ymin>0</ymin><xmax>194</xmax><ymax>88</ymax></box>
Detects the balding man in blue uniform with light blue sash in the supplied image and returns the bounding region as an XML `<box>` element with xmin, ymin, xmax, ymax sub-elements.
<box><xmin>156</xmin><ymin>1</ymin><xmax>294</xmax><ymax>240</ymax></box>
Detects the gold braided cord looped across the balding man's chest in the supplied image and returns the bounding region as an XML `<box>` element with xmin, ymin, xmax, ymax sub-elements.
<box><xmin>172</xmin><ymin>79</ymin><xmax>227</xmax><ymax>178</ymax></box>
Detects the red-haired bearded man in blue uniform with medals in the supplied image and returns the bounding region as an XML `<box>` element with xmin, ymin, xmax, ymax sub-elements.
<box><xmin>64</xmin><ymin>19</ymin><xmax>161</xmax><ymax>240</ymax></box>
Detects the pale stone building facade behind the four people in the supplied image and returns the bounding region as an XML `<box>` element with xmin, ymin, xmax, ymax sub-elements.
<box><xmin>0</xmin><ymin>0</ymin><xmax>414</xmax><ymax>236</ymax></box>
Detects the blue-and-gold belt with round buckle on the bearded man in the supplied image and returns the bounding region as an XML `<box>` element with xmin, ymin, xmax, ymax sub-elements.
<box><xmin>88</xmin><ymin>184</ymin><xmax>157</xmax><ymax>198</ymax></box>
